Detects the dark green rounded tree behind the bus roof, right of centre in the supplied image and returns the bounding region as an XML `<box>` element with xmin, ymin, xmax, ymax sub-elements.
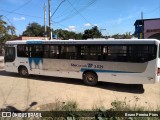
<box><xmin>83</xmin><ymin>26</ymin><xmax>102</xmax><ymax>39</ymax></box>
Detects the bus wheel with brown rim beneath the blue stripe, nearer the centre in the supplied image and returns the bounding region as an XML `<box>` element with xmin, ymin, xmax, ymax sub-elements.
<box><xmin>83</xmin><ymin>72</ymin><xmax>98</xmax><ymax>86</ymax></box>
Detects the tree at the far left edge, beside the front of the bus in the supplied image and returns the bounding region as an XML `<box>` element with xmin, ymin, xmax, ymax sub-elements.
<box><xmin>0</xmin><ymin>17</ymin><xmax>17</xmax><ymax>42</ymax></box>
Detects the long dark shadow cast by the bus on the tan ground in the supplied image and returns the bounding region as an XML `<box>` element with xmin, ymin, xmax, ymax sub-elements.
<box><xmin>0</xmin><ymin>70</ymin><xmax>144</xmax><ymax>94</ymax></box>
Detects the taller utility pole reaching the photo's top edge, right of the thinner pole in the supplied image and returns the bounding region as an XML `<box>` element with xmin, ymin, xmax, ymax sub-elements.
<box><xmin>48</xmin><ymin>0</ymin><xmax>52</xmax><ymax>40</ymax></box>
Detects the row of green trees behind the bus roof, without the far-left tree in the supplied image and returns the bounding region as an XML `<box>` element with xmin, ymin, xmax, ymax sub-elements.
<box><xmin>22</xmin><ymin>22</ymin><xmax>133</xmax><ymax>40</ymax></box>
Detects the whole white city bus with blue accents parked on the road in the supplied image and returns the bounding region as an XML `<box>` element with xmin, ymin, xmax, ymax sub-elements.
<box><xmin>5</xmin><ymin>39</ymin><xmax>160</xmax><ymax>86</ymax></box>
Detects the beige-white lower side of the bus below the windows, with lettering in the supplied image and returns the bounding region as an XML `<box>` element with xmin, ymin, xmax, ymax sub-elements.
<box><xmin>6</xmin><ymin>58</ymin><xmax>156</xmax><ymax>84</ymax></box>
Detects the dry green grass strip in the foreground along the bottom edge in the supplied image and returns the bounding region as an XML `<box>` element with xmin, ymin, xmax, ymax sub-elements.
<box><xmin>35</xmin><ymin>96</ymin><xmax>160</xmax><ymax>120</ymax></box>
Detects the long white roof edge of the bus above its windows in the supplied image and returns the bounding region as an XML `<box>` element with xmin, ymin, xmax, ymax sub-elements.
<box><xmin>6</xmin><ymin>39</ymin><xmax>160</xmax><ymax>45</ymax></box>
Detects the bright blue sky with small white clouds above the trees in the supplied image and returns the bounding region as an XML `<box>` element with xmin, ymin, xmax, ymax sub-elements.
<box><xmin>0</xmin><ymin>0</ymin><xmax>160</xmax><ymax>35</ymax></box>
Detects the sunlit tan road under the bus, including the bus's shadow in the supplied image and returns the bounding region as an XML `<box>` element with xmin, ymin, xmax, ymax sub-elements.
<box><xmin>0</xmin><ymin>70</ymin><xmax>160</xmax><ymax>110</ymax></box>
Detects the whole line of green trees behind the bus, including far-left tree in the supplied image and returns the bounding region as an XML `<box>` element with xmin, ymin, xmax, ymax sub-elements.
<box><xmin>0</xmin><ymin>19</ymin><xmax>133</xmax><ymax>42</ymax></box>
